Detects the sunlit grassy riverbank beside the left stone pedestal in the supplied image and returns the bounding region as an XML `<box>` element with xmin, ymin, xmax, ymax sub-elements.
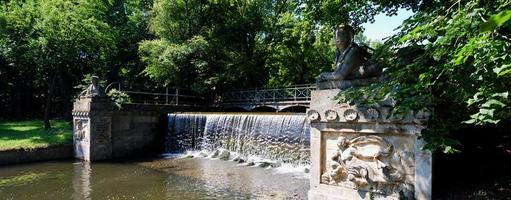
<box><xmin>0</xmin><ymin>120</ymin><xmax>73</xmax><ymax>165</ymax></box>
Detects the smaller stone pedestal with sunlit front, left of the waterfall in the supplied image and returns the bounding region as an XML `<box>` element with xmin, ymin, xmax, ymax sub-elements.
<box><xmin>73</xmin><ymin>97</ymin><xmax>113</xmax><ymax>161</ymax></box>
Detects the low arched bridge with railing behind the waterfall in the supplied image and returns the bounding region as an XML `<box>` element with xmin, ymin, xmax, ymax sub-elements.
<box><xmin>217</xmin><ymin>84</ymin><xmax>316</xmax><ymax>111</ymax></box>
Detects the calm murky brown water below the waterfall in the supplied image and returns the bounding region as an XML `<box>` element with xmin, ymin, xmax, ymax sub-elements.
<box><xmin>0</xmin><ymin>158</ymin><xmax>309</xmax><ymax>200</ymax></box>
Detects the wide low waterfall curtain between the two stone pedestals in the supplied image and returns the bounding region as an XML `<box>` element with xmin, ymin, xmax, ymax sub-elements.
<box><xmin>165</xmin><ymin>113</ymin><xmax>310</xmax><ymax>163</ymax></box>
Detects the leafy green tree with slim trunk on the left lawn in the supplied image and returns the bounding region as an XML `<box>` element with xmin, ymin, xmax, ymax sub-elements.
<box><xmin>0</xmin><ymin>0</ymin><xmax>115</xmax><ymax>128</ymax></box>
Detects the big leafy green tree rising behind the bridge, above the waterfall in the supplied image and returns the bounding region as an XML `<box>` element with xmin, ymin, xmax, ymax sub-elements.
<box><xmin>140</xmin><ymin>0</ymin><xmax>264</xmax><ymax>92</ymax></box>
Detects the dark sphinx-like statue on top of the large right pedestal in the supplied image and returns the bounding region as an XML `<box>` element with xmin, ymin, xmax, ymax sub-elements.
<box><xmin>318</xmin><ymin>24</ymin><xmax>381</xmax><ymax>82</ymax></box>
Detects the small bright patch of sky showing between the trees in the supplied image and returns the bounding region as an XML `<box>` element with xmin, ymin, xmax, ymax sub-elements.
<box><xmin>362</xmin><ymin>9</ymin><xmax>413</xmax><ymax>41</ymax></box>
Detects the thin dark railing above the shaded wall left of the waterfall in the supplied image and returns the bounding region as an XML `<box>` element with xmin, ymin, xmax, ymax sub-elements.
<box><xmin>105</xmin><ymin>82</ymin><xmax>205</xmax><ymax>105</ymax></box>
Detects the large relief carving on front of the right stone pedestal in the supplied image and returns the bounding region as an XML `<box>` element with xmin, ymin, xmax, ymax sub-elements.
<box><xmin>321</xmin><ymin>135</ymin><xmax>405</xmax><ymax>191</ymax></box>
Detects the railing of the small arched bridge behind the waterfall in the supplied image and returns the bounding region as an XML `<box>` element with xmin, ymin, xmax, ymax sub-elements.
<box><xmin>220</xmin><ymin>84</ymin><xmax>316</xmax><ymax>104</ymax></box>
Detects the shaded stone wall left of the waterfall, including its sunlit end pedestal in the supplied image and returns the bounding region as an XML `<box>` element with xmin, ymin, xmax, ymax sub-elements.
<box><xmin>73</xmin><ymin>97</ymin><xmax>204</xmax><ymax>161</ymax></box>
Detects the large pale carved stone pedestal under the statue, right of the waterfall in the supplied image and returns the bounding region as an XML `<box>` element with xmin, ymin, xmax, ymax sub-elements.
<box><xmin>307</xmin><ymin>89</ymin><xmax>431</xmax><ymax>200</ymax></box>
